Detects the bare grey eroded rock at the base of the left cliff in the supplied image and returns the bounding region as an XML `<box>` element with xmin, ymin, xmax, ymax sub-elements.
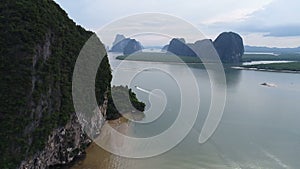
<box><xmin>19</xmin><ymin>103</ymin><xmax>107</xmax><ymax>169</ymax></box>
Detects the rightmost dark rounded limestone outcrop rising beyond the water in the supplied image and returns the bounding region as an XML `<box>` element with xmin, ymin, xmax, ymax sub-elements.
<box><xmin>213</xmin><ymin>32</ymin><xmax>244</xmax><ymax>63</ymax></box>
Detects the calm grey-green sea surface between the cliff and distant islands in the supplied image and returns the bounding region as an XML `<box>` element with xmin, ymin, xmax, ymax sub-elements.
<box><xmin>73</xmin><ymin>54</ymin><xmax>300</xmax><ymax>169</ymax></box>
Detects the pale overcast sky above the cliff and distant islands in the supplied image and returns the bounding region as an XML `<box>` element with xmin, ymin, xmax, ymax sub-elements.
<box><xmin>55</xmin><ymin>0</ymin><xmax>300</xmax><ymax>47</ymax></box>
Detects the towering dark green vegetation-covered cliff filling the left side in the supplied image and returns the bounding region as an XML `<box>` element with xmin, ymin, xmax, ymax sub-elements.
<box><xmin>0</xmin><ymin>0</ymin><xmax>111</xmax><ymax>169</ymax></box>
